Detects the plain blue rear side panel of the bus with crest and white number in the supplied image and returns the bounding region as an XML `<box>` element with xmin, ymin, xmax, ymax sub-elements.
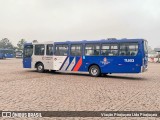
<box><xmin>83</xmin><ymin>56</ymin><xmax>141</xmax><ymax>73</ymax></box>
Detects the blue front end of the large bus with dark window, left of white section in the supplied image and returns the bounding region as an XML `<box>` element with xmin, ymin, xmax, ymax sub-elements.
<box><xmin>23</xmin><ymin>44</ymin><xmax>33</xmax><ymax>68</ymax></box>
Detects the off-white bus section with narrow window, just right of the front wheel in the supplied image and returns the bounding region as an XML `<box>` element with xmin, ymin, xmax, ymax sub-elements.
<box><xmin>44</xmin><ymin>44</ymin><xmax>54</xmax><ymax>70</ymax></box>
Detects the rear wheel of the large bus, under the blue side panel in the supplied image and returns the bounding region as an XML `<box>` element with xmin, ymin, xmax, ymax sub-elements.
<box><xmin>89</xmin><ymin>65</ymin><xmax>101</xmax><ymax>77</ymax></box>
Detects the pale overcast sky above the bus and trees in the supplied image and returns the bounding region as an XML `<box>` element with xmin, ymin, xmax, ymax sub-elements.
<box><xmin>0</xmin><ymin>0</ymin><xmax>160</xmax><ymax>47</ymax></box>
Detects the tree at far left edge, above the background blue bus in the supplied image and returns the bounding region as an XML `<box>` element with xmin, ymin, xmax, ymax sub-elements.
<box><xmin>0</xmin><ymin>38</ymin><xmax>13</xmax><ymax>49</ymax></box>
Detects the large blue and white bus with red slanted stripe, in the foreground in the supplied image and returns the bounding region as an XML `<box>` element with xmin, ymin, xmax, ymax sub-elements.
<box><xmin>23</xmin><ymin>39</ymin><xmax>148</xmax><ymax>77</ymax></box>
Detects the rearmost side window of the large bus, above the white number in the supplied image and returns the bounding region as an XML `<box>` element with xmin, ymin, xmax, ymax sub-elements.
<box><xmin>119</xmin><ymin>43</ymin><xmax>138</xmax><ymax>56</ymax></box>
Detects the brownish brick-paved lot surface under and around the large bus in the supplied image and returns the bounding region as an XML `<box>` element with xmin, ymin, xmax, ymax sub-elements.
<box><xmin>0</xmin><ymin>59</ymin><xmax>160</xmax><ymax>119</ymax></box>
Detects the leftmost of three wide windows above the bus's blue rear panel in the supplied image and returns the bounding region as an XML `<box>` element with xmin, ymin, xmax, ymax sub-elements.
<box><xmin>85</xmin><ymin>44</ymin><xmax>100</xmax><ymax>56</ymax></box>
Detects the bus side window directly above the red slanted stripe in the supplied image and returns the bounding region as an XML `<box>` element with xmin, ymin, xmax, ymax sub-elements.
<box><xmin>71</xmin><ymin>44</ymin><xmax>82</xmax><ymax>56</ymax></box>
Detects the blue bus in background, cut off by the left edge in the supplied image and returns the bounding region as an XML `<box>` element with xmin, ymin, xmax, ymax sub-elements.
<box><xmin>0</xmin><ymin>49</ymin><xmax>15</xmax><ymax>59</ymax></box>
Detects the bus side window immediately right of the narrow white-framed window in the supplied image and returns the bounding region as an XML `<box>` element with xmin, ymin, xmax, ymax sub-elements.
<box><xmin>55</xmin><ymin>45</ymin><xmax>68</xmax><ymax>56</ymax></box>
